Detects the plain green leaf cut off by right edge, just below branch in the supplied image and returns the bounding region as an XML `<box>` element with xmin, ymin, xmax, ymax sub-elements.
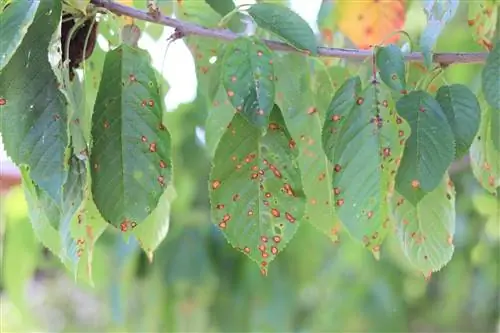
<box><xmin>481</xmin><ymin>41</ymin><xmax>500</xmax><ymax>112</ymax></box>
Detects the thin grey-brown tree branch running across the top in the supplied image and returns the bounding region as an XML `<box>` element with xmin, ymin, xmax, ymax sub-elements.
<box><xmin>91</xmin><ymin>0</ymin><xmax>488</xmax><ymax>65</ymax></box>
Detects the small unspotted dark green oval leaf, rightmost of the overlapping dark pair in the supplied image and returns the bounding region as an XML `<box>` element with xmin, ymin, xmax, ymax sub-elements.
<box><xmin>436</xmin><ymin>84</ymin><xmax>481</xmax><ymax>159</ymax></box>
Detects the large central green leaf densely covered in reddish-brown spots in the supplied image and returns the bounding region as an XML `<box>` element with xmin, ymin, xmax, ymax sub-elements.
<box><xmin>209</xmin><ymin>107</ymin><xmax>305</xmax><ymax>274</ymax></box>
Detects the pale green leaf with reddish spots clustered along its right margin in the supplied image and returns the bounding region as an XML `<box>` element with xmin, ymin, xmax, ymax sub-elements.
<box><xmin>324</xmin><ymin>79</ymin><xmax>405</xmax><ymax>252</ymax></box>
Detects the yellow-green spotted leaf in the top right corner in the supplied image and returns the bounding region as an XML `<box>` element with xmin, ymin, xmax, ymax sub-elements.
<box><xmin>467</xmin><ymin>0</ymin><xmax>498</xmax><ymax>49</ymax></box>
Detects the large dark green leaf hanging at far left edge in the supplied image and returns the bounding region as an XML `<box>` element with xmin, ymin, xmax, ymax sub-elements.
<box><xmin>0</xmin><ymin>0</ymin><xmax>68</xmax><ymax>202</ymax></box>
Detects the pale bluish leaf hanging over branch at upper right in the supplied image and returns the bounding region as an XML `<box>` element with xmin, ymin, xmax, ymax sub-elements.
<box><xmin>420</xmin><ymin>0</ymin><xmax>459</xmax><ymax>68</ymax></box>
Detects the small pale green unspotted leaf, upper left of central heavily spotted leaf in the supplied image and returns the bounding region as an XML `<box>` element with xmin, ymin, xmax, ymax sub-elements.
<box><xmin>205</xmin><ymin>85</ymin><xmax>235</xmax><ymax>157</ymax></box>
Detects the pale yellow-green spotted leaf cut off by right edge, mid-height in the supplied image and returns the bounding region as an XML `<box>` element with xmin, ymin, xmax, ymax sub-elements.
<box><xmin>470</xmin><ymin>98</ymin><xmax>500</xmax><ymax>194</ymax></box>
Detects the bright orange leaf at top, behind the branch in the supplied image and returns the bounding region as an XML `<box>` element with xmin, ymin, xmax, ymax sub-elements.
<box><xmin>336</xmin><ymin>0</ymin><xmax>406</xmax><ymax>49</ymax></box>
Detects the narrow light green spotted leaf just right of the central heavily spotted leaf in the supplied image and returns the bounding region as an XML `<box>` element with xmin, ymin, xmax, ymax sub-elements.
<box><xmin>276</xmin><ymin>54</ymin><xmax>339</xmax><ymax>241</ymax></box>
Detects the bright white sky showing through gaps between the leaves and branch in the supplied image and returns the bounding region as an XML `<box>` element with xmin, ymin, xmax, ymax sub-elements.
<box><xmin>0</xmin><ymin>0</ymin><xmax>321</xmax><ymax>165</ymax></box>
